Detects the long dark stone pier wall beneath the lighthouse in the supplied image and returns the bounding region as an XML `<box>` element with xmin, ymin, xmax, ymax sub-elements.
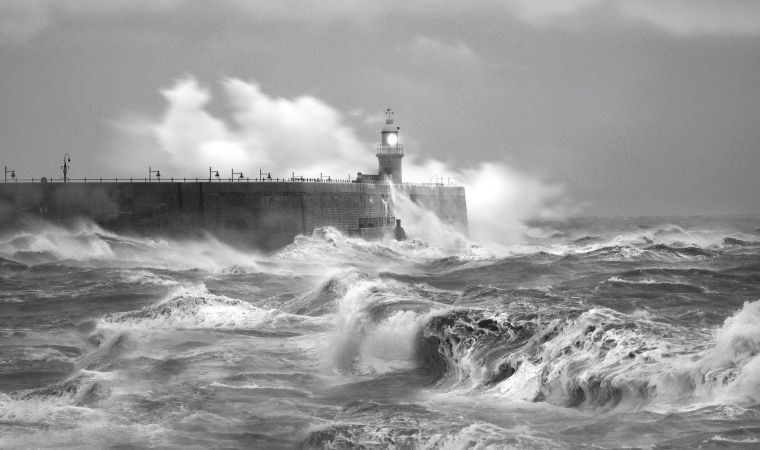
<box><xmin>0</xmin><ymin>182</ymin><xmax>467</xmax><ymax>250</ymax></box>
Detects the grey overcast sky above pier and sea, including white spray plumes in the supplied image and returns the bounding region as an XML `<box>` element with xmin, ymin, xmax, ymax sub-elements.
<box><xmin>0</xmin><ymin>0</ymin><xmax>760</xmax><ymax>219</ymax></box>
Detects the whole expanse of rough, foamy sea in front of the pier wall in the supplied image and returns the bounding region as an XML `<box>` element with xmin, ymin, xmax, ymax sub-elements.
<box><xmin>0</xmin><ymin>214</ymin><xmax>760</xmax><ymax>448</ymax></box>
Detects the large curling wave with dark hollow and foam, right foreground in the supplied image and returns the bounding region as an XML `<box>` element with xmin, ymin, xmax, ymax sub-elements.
<box><xmin>419</xmin><ymin>301</ymin><xmax>760</xmax><ymax>409</ymax></box>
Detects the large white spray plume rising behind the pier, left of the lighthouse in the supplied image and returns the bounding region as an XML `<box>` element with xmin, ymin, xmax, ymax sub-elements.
<box><xmin>112</xmin><ymin>78</ymin><xmax>372</xmax><ymax>178</ymax></box>
